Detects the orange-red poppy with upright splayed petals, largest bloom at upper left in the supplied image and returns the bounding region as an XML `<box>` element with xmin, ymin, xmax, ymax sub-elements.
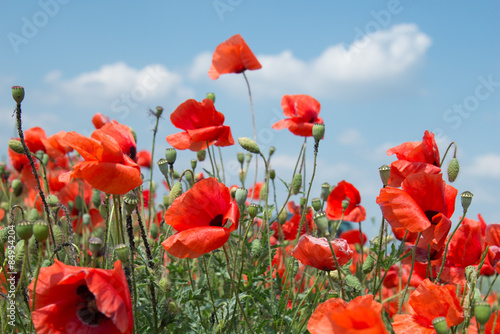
<box><xmin>59</xmin><ymin>130</ymin><xmax>142</xmax><ymax>194</ymax></box>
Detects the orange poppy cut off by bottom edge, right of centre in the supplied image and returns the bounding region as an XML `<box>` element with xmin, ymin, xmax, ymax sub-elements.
<box><xmin>307</xmin><ymin>295</ymin><xmax>387</xmax><ymax>334</ymax></box>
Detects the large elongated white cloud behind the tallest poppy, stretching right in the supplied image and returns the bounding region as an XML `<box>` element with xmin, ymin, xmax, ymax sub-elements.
<box><xmin>190</xmin><ymin>24</ymin><xmax>431</xmax><ymax>98</ymax></box>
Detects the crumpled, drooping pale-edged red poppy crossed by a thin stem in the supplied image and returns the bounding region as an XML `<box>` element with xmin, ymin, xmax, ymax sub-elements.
<box><xmin>292</xmin><ymin>234</ymin><xmax>353</xmax><ymax>271</ymax></box>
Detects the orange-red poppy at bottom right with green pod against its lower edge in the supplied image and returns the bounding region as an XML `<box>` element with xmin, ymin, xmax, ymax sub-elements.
<box><xmin>392</xmin><ymin>279</ymin><xmax>464</xmax><ymax>334</ymax></box>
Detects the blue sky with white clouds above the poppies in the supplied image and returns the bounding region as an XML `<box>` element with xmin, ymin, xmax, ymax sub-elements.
<box><xmin>0</xmin><ymin>0</ymin><xmax>500</xmax><ymax>235</ymax></box>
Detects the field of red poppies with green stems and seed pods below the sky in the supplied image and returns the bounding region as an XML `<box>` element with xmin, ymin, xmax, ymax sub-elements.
<box><xmin>0</xmin><ymin>35</ymin><xmax>500</xmax><ymax>334</ymax></box>
